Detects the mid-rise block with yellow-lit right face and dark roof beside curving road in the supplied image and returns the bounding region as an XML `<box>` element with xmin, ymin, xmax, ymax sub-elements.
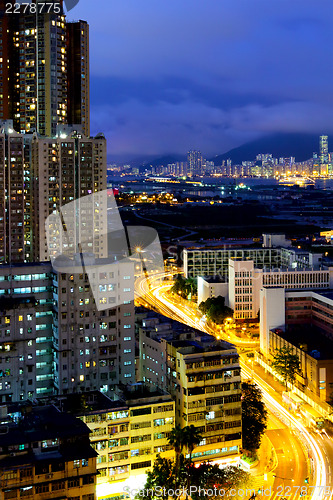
<box><xmin>138</xmin><ymin>312</ymin><xmax>242</xmax><ymax>460</ymax></box>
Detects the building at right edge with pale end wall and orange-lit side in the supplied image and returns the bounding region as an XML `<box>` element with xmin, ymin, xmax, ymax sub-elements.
<box><xmin>260</xmin><ymin>288</ymin><xmax>333</xmax><ymax>401</ymax></box>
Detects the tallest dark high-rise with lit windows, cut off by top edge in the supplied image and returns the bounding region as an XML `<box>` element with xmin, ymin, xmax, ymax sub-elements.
<box><xmin>0</xmin><ymin>0</ymin><xmax>89</xmax><ymax>137</ymax></box>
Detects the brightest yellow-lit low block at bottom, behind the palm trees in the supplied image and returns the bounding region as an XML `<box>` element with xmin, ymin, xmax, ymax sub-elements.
<box><xmin>54</xmin><ymin>390</ymin><xmax>175</xmax><ymax>499</ymax></box>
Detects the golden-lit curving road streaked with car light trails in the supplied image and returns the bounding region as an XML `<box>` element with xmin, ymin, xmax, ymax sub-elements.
<box><xmin>136</xmin><ymin>273</ymin><xmax>333</xmax><ymax>500</ymax></box>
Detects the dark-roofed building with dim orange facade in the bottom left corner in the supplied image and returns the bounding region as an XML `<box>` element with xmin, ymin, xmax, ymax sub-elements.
<box><xmin>0</xmin><ymin>403</ymin><xmax>97</xmax><ymax>500</ymax></box>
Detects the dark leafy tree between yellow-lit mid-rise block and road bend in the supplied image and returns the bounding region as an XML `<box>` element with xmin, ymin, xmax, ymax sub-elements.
<box><xmin>242</xmin><ymin>382</ymin><xmax>267</xmax><ymax>455</ymax></box>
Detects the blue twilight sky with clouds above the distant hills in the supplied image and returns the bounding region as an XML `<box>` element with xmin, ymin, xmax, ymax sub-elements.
<box><xmin>68</xmin><ymin>0</ymin><xmax>333</xmax><ymax>158</ymax></box>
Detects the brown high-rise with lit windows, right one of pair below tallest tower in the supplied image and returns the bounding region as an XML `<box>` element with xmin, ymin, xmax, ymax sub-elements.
<box><xmin>31</xmin><ymin>127</ymin><xmax>107</xmax><ymax>262</ymax></box>
